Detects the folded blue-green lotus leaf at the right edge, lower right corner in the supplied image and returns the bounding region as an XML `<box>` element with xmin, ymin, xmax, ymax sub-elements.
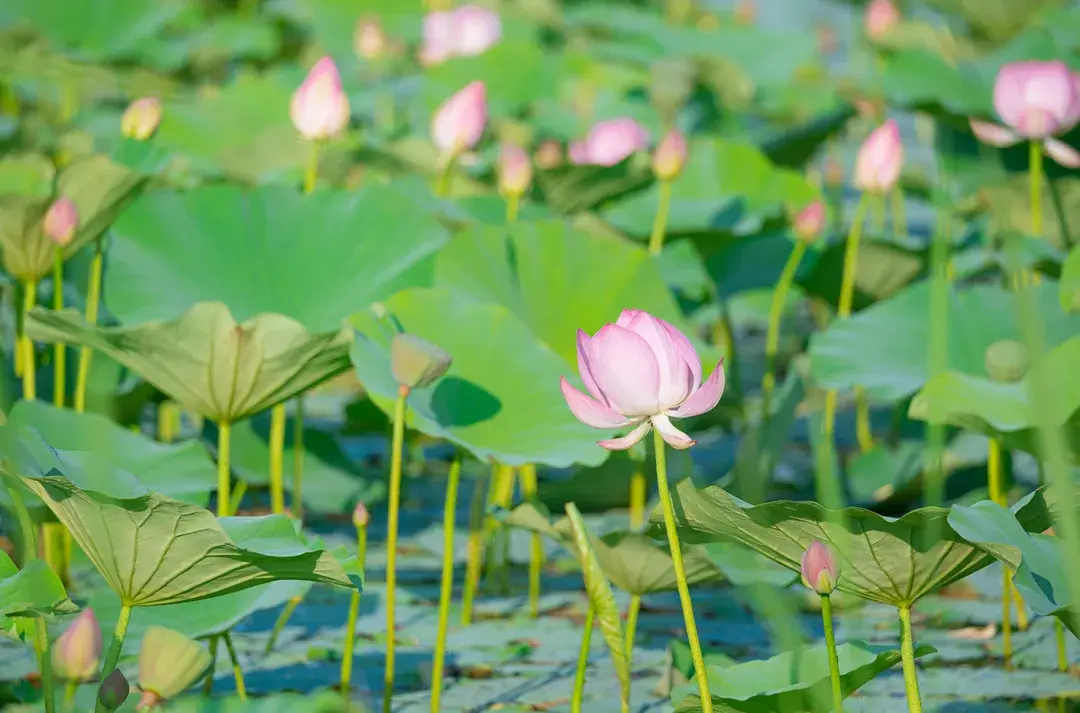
<box><xmin>948</xmin><ymin>500</ymin><xmax>1080</xmax><ymax>636</ymax></box>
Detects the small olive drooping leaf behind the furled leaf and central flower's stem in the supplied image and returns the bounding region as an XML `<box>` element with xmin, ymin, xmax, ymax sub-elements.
<box><xmin>499</xmin><ymin>502</ymin><xmax>725</xmax><ymax>595</ymax></box>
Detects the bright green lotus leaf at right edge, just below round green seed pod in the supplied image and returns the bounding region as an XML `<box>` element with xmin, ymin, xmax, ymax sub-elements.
<box><xmin>908</xmin><ymin>337</ymin><xmax>1080</xmax><ymax>453</ymax></box>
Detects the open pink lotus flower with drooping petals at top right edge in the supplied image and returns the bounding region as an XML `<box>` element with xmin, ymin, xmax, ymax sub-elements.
<box><xmin>971</xmin><ymin>60</ymin><xmax>1080</xmax><ymax>169</ymax></box>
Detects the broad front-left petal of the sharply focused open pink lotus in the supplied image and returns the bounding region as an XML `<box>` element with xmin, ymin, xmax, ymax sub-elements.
<box><xmin>589</xmin><ymin>324</ymin><xmax>660</xmax><ymax>418</ymax></box>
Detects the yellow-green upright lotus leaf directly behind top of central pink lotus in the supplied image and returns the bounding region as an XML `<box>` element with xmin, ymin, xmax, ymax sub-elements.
<box><xmin>435</xmin><ymin>220</ymin><xmax>689</xmax><ymax>368</ymax></box>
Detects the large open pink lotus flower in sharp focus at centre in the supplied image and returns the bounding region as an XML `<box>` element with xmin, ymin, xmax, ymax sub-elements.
<box><xmin>559</xmin><ymin>309</ymin><xmax>725</xmax><ymax>450</ymax></box>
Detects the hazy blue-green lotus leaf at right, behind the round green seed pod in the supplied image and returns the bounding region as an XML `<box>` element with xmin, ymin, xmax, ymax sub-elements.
<box><xmin>810</xmin><ymin>281</ymin><xmax>1080</xmax><ymax>401</ymax></box>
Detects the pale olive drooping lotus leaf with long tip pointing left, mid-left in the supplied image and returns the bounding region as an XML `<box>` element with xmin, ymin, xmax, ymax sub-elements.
<box><xmin>27</xmin><ymin>302</ymin><xmax>352</xmax><ymax>422</ymax></box>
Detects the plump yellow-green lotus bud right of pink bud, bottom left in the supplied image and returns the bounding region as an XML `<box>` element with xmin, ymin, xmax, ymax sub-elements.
<box><xmin>138</xmin><ymin>627</ymin><xmax>213</xmax><ymax>708</ymax></box>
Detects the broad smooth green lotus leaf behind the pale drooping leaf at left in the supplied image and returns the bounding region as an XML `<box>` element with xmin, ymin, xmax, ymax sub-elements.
<box><xmin>105</xmin><ymin>186</ymin><xmax>448</xmax><ymax>332</ymax></box>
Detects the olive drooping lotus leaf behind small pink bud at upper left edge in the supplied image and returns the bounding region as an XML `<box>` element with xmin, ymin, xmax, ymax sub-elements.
<box><xmin>0</xmin><ymin>156</ymin><xmax>145</xmax><ymax>281</ymax></box>
